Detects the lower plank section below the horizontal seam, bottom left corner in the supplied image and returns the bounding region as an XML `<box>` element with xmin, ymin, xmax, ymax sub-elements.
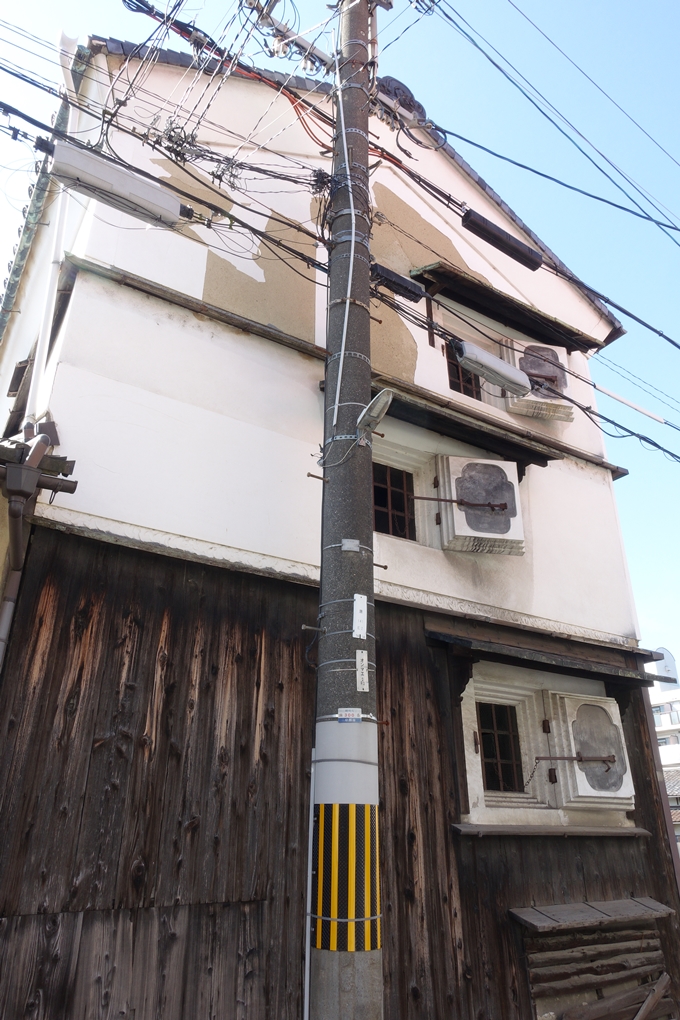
<box><xmin>0</xmin><ymin>901</ymin><xmax>302</xmax><ymax>1020</ymax></box>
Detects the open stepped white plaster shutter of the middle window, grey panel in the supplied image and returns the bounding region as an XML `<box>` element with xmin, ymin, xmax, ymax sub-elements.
<box><xmin>436</xmin><ymin>457</ymin><xmax>524</xmax><ymax>556</ymax></box>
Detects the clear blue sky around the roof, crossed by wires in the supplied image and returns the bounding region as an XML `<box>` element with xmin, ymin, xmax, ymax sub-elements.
<box><xmin>0</xmin><ymin>0</ymin><xmax>680</xmax><ymax>657</ymax></box>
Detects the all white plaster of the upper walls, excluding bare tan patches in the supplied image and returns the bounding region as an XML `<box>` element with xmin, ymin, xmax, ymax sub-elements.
<box><xmin>0</xmin><ymin>53</ymin><xmax>637</xmax><ymax>644</ymax></box>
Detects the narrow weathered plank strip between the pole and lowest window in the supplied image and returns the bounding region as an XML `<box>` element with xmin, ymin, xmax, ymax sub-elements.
<box><xmin>376</xmin><ymin>604</ymin><xmax>464</xmax><ymax>1020</ymax></box>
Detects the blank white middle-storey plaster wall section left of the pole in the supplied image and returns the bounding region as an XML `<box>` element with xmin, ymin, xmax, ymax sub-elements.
<box><xmin>39</xmin><ymin>275</ymin><xmax>321</xmax><ymax>573</ymax></box>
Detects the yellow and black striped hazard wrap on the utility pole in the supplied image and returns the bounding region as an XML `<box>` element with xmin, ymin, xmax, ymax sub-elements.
<box><xmin>311</xmin><ymin>804</ymin><xmax>382</xmax><ymax>953</ymax></box>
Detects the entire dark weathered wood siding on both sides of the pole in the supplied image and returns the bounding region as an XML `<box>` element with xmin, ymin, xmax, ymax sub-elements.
<box><xmin>0</xmin><ymin>528</ymin><xmax>680</xmax><ymax>1020</ymax></box>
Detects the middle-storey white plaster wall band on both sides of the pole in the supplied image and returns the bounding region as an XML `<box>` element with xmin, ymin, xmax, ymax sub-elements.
<box><xmin>30</xmin><ymin>273</ymin><xmax>636</xmax><ymax>642</ymax></box>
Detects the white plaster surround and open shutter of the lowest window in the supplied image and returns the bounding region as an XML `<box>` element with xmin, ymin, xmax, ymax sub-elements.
<box><xmin>462</xmin><ymin>662</ymin><xmax>634</xmax><ymax>826</ymax></box>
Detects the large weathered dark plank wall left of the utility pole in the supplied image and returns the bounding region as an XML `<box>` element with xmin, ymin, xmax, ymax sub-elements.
<box><xmin>0</xmin><ymin>528</ymin><xmax>317</xmax><ymax>1020</ymax></box>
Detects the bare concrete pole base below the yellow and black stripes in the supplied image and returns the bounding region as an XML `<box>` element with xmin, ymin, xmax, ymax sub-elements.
<box><xmin>310</xmin><ymin>949</ymin><xmax>382</xmax><ymax>1020</ymax></box>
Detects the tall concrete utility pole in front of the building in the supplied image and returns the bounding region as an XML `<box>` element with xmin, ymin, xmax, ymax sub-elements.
<box><xmin>310</xmin><ymin>0</ymin><xmax>382</xmax><ymax>1020</ymax></box>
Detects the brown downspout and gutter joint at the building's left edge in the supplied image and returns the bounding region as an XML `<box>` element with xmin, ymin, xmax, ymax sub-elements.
<box><xmin>0</xmin><ymin>435</ymin><xmax>77</xmax><ymax>670</ymax></box>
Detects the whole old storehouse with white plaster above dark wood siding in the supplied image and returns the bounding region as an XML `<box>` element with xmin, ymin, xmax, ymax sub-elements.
<box><xmin>0</xmin><ymin>31</ymin><xmax>680</xmax><ymax>1020</ymax></box>
